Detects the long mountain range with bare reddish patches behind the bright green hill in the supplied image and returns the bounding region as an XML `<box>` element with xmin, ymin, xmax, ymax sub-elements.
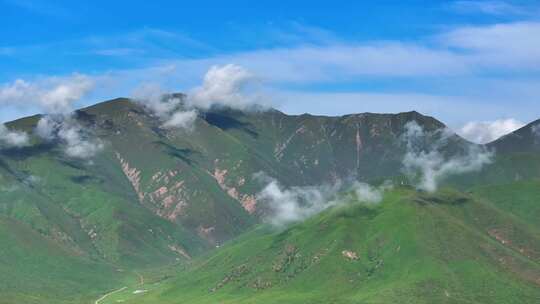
<box><xmin>0</xmin><ymin>98</ymin><xmax>540</xmax><ymax>303</ymax></box>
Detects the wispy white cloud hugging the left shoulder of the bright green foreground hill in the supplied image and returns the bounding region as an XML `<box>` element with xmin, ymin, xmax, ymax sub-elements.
<box><xmin>255</xmin><ymin>173</ymin><xmax>390</xmax><ymax>227</ymax></box>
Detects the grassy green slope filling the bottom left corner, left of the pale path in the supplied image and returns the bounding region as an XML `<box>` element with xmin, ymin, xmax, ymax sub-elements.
<box><xmin>0</xmin><ymin>215</ymin><xmax>130</xmax><ymax>304</ymax></box>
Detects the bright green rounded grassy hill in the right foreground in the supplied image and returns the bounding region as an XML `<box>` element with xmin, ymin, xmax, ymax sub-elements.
<box><xmin>102</xmin><ymin>189</ymin><xmax>540</xmax><ymax>303</ymax></box>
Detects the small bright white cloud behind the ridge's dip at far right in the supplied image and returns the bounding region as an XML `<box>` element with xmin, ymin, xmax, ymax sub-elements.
<box><xmin>458</xmin><ymin>118</ymin><xmax>525</xmax><ymax>144</ymax></box>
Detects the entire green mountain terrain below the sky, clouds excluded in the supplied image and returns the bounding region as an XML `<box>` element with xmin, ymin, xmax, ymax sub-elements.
<box><xmin>0</xmin><ymin>99</ymin><xmax>540</xmax><ymax>303</ymax></box>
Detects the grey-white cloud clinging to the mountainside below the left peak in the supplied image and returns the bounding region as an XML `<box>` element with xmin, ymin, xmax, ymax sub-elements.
<box><xmin>35</xmin><ymin>115</ymin><xmax>104</xmax><ymax>159</ymax></box>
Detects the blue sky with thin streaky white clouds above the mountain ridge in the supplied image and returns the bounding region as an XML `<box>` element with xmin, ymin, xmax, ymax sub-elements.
<box><xmin>0</xmin><ymin>0</ymin><xmax>540</xmax><ymax>142</ymax></box>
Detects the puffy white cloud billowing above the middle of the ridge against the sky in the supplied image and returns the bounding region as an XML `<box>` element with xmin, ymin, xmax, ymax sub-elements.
<box><xmin>187</xmin><ymin>64</ymin><xmax>261</xmax><ymax>109</ymax></box>
